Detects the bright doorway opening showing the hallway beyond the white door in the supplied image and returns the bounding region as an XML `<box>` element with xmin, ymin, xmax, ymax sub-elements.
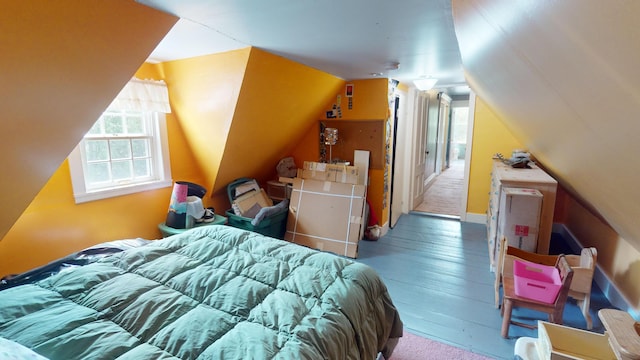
<box><xmin>414</xmin><ymin>100</ymin><xmax>469</xmax><ymax>219</ymax></box>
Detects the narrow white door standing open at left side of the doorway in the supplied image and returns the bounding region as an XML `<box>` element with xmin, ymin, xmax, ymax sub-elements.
<box><xmin>410</xmin><ymin>92</ymin><xmax>429</xmax><ymax>209</ymax></box>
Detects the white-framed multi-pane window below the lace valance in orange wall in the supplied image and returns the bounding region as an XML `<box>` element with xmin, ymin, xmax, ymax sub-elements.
<box><xmin>69</xmin><ymin>77</ymin><xmax>172</xmax><ymax>203</ymax></box>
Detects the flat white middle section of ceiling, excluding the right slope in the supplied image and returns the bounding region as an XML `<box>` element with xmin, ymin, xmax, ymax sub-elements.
<box><xmin>137</xmin><ymin>0</ymin><xmax>468</xmax><ymax>93</ymax></box>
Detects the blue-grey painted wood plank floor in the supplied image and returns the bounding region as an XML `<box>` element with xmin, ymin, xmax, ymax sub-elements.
<box><xmin>357</xmin><ymin>213</ymin><xmax>611</xmax><ymax>359</ymax></box>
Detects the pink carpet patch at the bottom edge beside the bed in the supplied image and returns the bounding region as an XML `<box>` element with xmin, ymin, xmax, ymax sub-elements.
<box><xmin>389</xmin><ymin>331</ymin><xmax>491</xmax><ymax>360</ymax></box>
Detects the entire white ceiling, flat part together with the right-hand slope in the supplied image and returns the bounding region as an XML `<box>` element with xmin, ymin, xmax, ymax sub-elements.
<box><xmin>137</xmin><ymin>0</ymin><xmax>640</xmax><ymax>249</ymax></box>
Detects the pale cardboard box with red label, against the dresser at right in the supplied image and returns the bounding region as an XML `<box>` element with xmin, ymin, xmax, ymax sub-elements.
<box><xmin>496</xmin><ymin>187</ymin><xmax>542</xmax><ymax>253</ymax></box>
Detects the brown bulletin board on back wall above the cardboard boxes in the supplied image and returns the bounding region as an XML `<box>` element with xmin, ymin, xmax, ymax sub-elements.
<box><xmin>319</xmin><ymin>120</ymin><xmax>385</xmax><ymax>169</ymax></box>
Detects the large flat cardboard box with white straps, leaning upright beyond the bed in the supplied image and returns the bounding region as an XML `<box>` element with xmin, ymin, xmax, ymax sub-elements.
<box><xmin>285</xmin><ymin>178</ymin><xmax>366</xmax><ymax>258</ymax></box>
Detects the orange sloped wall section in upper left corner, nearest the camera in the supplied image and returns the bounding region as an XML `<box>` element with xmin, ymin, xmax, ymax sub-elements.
<box><xmin>0</xmin><ymin>0</ymin><xmax>178</xmax><ymax>242</ymax></box>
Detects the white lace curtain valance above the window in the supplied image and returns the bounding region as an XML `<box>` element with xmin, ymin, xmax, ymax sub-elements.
<box><xmin>109</xmin><ymin>78</ymin><xmax>171</xmax><ymax>113</ymax></box>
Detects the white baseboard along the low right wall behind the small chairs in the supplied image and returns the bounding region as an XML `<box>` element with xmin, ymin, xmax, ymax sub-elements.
<box><xmin>552</xmin><ymin>223</ymin><xmax>640</xmax><ymax>320</ymax></box>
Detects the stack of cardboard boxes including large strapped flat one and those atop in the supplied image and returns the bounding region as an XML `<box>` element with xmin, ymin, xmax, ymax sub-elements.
<box><xmin>280</xmin><ymin>151</ymin><xmax>369</xmax><ymax>258</ymax></box>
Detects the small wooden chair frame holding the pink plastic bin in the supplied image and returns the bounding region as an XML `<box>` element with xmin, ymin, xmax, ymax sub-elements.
<box><xmin>500</xmin><ymin>255</ymin><xmax>573</xmax><ymax>338</ymax></box>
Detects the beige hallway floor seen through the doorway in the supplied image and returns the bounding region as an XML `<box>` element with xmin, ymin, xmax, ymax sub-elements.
<box><xmin>413</xmin><ymin>160</ymin><xmax>464</xmax><ymax>217</ymax></box>
